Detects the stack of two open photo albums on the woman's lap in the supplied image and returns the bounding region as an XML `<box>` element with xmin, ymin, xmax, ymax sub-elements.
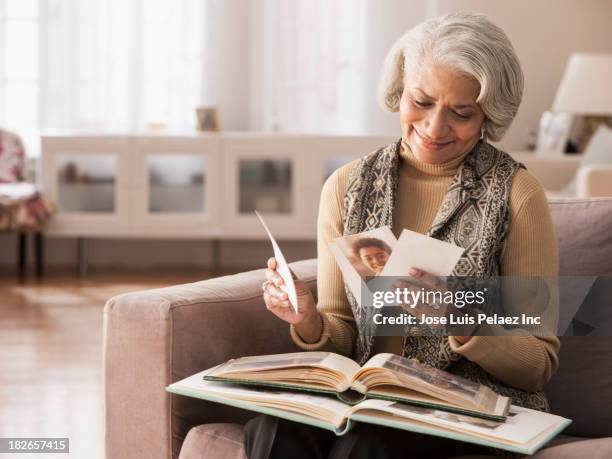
<box><xmin>166</xmin><ymin>352</ymin><xmax>571</xmax><ymax>454</ymax></box>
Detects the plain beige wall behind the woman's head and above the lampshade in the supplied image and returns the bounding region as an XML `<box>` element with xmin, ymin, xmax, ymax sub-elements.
<box><xmin>354</xmin><ymin>0</ymin><xmax>612</xmax><ymax>151</ymax></box>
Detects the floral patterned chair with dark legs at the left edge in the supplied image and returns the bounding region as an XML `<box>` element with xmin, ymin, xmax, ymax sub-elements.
<box><xmin>0</xmin><ymin>129</ymin><xmax>54</xmax><ymax>278</ymax></box>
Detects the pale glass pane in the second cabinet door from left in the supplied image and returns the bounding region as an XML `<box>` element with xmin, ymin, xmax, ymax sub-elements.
<box><xmin>147</xmin><ymin>154</ymin><xmax>206</xmax><ymax>213</ymax></box>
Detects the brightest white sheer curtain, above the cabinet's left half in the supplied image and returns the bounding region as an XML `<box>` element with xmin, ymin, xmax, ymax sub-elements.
<box><xmin>39</xmin><ymin>0</ymin><xmax>209</xmax><ymax>131</ymax></box>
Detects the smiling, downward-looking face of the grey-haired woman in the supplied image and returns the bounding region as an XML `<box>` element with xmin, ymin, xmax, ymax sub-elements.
<box><xmin>400</xmin><ymin>64</ymin><xmax>484</xmax><ymax>164</ymax></box>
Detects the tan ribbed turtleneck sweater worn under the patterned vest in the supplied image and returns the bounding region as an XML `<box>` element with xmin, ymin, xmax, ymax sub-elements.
<box><xmin>291</xmin><ymin>143</ymin><xmax>559</xmax><ymax>391</ymax></box>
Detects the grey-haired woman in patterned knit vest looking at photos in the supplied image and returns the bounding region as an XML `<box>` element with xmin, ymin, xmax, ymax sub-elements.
<box><xmin>245</xmin><ymin>14</ymin><xmax>559</xmax><ymax>458</ymax></box>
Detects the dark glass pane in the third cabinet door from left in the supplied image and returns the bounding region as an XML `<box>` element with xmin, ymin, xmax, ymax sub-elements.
<box><xmin>239</xmin><ymin>159</ymin><xmax>292</xmax><ymax>214</ymax></box>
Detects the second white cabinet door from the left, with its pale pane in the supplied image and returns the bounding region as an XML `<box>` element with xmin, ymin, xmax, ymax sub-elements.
<box><xmin>132</xmin><ymin>136</ymin><xmax>220</xmax><ymax>238</ymax></box>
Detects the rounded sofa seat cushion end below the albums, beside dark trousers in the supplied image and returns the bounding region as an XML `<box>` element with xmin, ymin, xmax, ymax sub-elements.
<box><xmin>179</xmin><ymin>424</ymin><xmax>246</xmax><ymax>459</ymax></box>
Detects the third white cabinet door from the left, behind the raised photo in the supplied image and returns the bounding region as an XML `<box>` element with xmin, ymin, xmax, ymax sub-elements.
<box><xmin>220</xmin><ymin>137</ymin><xmax>312</xmax><ymax>239</ymax></box>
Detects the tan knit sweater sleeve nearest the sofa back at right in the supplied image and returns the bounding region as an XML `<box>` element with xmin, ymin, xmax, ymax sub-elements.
<box><xmin>449</xmin><ymin>170</ymin><xmax>559</xmax><ymax>391</ymax></box>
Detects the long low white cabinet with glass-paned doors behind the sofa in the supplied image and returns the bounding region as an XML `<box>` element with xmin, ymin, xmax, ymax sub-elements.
<box><xmin>42</xmin><ymin>133</ymin><xmax>396</xmax><ymax>239</ymax></box>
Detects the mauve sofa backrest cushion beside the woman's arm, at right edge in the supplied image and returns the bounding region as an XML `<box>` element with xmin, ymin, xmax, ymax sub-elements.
<box><xmin>546</xmin><ymin>198</ymin><xmax>612</xmax><ymax>437</ymax></box>
